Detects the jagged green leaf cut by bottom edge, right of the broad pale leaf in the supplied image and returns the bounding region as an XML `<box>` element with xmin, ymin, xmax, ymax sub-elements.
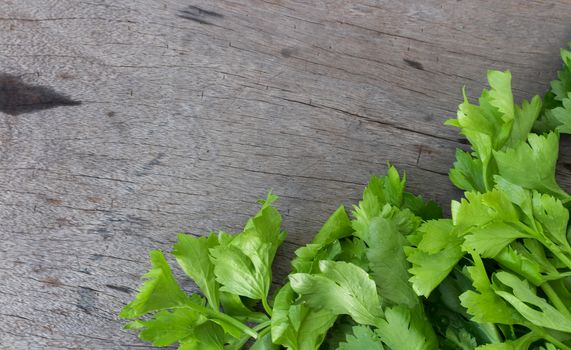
<box><xmin>377</xmin><ymin>305</ymin><xmax>438</xmax><ymax>350</ymax></box>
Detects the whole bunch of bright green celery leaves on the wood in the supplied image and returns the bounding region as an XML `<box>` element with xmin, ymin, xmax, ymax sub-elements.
<box><xmin>119</xmin><ymin>42</ymin><xmax>571</xmax><ymax>350</ymax></box>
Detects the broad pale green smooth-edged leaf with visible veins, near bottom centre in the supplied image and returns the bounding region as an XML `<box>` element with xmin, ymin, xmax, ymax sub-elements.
<box><xmin>289</xmin><ymin>260</ymin><xmax>383</xmax><ymax>325</ymax></box>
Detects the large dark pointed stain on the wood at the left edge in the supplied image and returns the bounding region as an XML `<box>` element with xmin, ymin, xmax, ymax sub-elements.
<box><xmin>0</xmin><ymin>73</ymin><xmax>81</xmax><ymax>115</ymax></box>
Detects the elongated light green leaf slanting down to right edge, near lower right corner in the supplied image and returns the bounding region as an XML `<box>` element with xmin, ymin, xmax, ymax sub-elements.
<box><xmin>493</xmin><ymin>271</ymin><xmax>571</xmax><ymax>333</ymax></box>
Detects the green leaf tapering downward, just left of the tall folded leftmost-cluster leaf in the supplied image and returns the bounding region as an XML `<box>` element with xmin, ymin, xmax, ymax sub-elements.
<box><xmin>172</xmin><ymin>234</ymin><xmax>219</xmax><ymax>310</ymax></box>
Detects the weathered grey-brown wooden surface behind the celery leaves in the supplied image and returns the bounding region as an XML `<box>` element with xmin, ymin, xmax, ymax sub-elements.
<box><xmin>0</xmin><ymin>0</ymin><xmax>571</xmax><ymax>349</ymax></box>
